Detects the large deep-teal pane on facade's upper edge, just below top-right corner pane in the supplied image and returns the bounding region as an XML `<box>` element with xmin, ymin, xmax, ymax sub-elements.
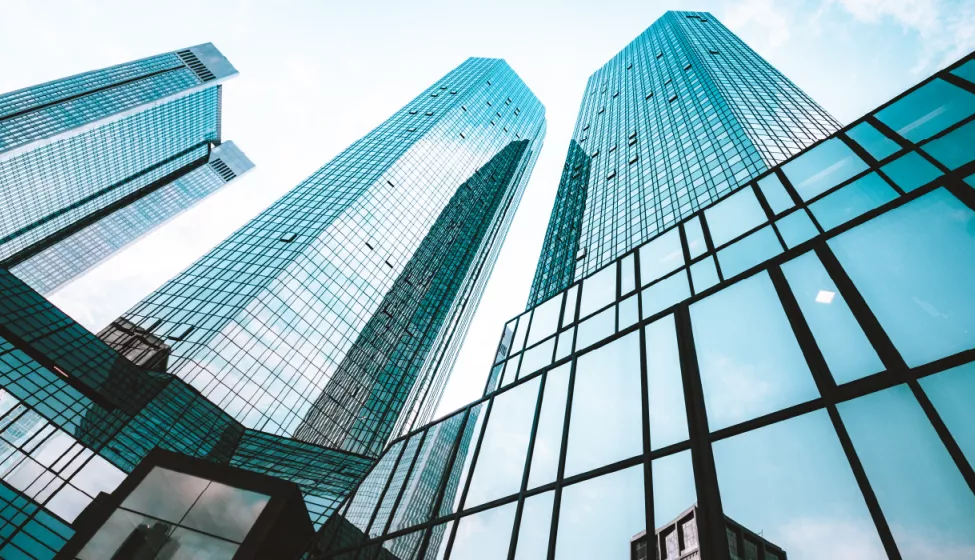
<box><xmin>876</xmin><ymin>78</ymin><xmax>975</xmax><ymax>142</ymax></box>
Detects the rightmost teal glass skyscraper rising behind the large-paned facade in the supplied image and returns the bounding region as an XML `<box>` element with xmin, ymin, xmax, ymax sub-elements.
<box><xmin>529</xmin><ymin>12</ymin><xmax>839</xmax><ymax>306</ymax></box>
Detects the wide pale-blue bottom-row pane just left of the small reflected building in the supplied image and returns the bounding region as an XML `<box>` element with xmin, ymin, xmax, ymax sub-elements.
<box><xmin>555</xmin><ymin>465</ymin><xmax>647</xmax><ymax>560</ymax></box>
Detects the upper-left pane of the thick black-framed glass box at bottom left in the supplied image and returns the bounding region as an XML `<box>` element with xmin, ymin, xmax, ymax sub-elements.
<box><xmin>122</xmin><ymin>467</ymin><xmax>210</xmax><ymax>523</ymax></box>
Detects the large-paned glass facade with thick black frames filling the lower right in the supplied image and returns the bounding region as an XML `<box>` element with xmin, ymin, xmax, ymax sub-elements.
<box><xmin>308</xmin><ymin>50</ymin><xmax>975</xmax><ymax>560</ymax></box>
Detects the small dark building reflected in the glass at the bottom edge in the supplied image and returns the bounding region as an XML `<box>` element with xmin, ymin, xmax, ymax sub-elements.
<box><xmin>630</xmin><ymin>505</ymin><xmax>786</xmax><ymax>560</ymax></box>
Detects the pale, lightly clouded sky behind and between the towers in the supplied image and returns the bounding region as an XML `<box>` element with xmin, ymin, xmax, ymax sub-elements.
<box><xmin>0</xmin><ymin>0</ymin><xmax>975</xmax><ymax>415</ymax></box>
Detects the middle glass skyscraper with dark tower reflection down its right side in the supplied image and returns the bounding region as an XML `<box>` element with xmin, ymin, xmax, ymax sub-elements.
<box><xmin>117</xmin><ymin>58</ymin><xmax>545</xmax><ymax>455</ymax></box>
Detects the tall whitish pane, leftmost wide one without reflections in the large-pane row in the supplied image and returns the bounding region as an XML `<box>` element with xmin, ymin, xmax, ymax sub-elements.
<box><xmin>464</xmin><ymin>377</ymin><xmax>541</xmax><ymax>508</ymax></box>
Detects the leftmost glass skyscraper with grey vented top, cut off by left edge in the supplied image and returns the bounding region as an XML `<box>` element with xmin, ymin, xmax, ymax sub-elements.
<box><xmin>0</xmin><ymin>43</ymin><xmax>244</xmax><ymax>293</ymax></box>
